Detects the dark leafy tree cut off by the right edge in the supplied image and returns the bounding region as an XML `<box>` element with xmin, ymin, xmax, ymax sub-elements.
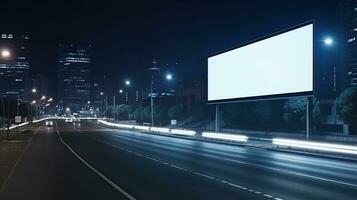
<box><xmin>336</xmin><ymin>86</ymin><xmax>357</xmax><ymax>132</ymax></box>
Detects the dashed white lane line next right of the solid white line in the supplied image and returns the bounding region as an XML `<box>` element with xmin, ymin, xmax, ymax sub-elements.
<box><xmin>92</xmin><ymin>138</ymin><xmax>283</xmax><ymax>200</ymax></box>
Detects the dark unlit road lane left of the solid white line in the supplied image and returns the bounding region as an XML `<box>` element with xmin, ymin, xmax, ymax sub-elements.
<box><xmin>0</xmin><ymin>123</ymin><xmax>127</xmax><ymax>200</ymax></box>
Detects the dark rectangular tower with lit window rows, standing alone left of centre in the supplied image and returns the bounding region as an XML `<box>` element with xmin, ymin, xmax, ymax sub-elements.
<box><xmin>58</xmin><ymin>44</ymin><xmax>91</xmax><ymax>112</ymax></box>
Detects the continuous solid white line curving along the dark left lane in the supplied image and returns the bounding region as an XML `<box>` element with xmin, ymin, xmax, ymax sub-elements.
<box><xmin>56</xmin><ymin>123</ymin><xmax>136</xmax><ymax>200</ymax></box>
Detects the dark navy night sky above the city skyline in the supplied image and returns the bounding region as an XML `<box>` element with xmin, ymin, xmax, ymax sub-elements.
<box><xmin>0</xmin><ymin>0</ymin><xmax>338</xmax><ymax>94</ymax></box>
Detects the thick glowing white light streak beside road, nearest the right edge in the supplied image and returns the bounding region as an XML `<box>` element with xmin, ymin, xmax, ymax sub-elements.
<box><xmin>273</xmin><ymin>138</ymin><xmax>357</xmax><ymax>155</ymax></box>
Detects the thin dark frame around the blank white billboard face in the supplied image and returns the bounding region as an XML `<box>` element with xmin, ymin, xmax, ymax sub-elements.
<box><xmin>206</xmin><ymin>20</ymin><xmax>315</xmax><ymax>105</ymax></box>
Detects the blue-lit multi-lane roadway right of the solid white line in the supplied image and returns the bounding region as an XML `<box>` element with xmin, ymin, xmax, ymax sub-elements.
<box><xmin>59</xmin><ymin>122</ymin><xmax>357</xmax><ymax>200</ymax></box>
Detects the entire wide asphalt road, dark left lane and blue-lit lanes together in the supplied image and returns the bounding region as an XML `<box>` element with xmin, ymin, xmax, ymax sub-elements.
<box><xmin>0</xmin><ymin>121</ymin><xmax>357</xmax><ymax>200</ymax></box>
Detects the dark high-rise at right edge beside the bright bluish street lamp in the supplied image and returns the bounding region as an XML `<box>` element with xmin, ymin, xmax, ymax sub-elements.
<box><xmin>337</xmin><ymin>0</ymin><xmax>357</xmax><ymax>91</ymax></box>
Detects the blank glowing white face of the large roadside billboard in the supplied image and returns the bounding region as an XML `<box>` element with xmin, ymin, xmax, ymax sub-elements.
<box><xmin>208</xmin><ymin>24</ymin><xmax>313</xmax><ymax>103</ymax></box>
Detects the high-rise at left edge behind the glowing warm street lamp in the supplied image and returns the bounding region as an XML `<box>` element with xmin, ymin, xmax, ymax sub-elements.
<box><xmin>0</xmin><ymin>33</ymin><xmax>31</xmax><ymax>101</ymax></box>
